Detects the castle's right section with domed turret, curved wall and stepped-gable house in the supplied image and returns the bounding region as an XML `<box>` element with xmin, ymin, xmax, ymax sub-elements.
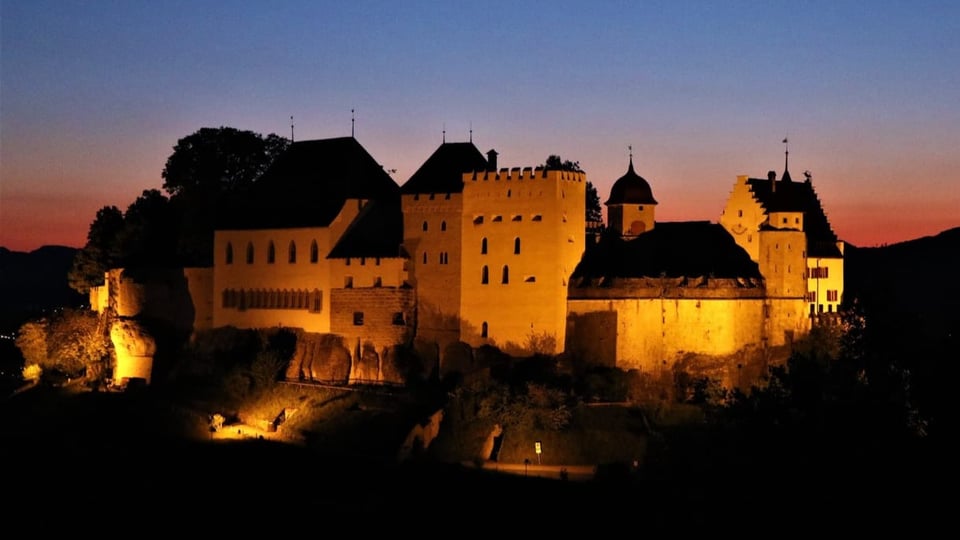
<box><xmin>566</xmin><ymin>148</ymin><xmax>843</xmax><ymax>383</ymax></box>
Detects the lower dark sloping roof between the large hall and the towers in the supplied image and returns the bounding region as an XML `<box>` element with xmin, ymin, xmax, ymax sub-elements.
<box><xmin>327</xmin><ymin>197</ymin><xmax>403</xmax><ymax>259</ymax></box>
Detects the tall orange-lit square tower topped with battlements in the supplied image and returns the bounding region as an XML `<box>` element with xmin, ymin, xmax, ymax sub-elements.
<box><xmin>460</xmin><ymin>168</ymin><xmax>586</xmax><ymax>355</ymax></box>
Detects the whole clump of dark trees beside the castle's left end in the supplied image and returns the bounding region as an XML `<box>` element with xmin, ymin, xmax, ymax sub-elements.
<box><xmin>69</xmin><ymin>127</ymin><xmax>289</xmax><ymax>280</ymax></box>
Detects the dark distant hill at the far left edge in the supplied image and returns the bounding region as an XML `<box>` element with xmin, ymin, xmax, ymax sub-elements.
<box><xmin>0</xmin><ymin>246</ymin><xmax>87</xmax><ymax>330</ymax></box>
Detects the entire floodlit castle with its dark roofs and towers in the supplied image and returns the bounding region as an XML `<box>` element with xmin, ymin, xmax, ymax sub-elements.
<box><xmin>94</xmin><ymin>137</ymin><xmax>843</xmax><ymax>388</ymax></box>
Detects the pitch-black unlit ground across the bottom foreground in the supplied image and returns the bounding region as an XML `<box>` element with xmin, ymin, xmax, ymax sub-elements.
<box><xmin>0</xmin><ymin>389</ymin><xmax>953</xmax><ymax>538</ymax></box>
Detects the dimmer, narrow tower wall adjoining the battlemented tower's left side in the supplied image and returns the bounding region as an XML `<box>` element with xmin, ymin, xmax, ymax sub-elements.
<box><xmin>402</xmin><ymin>193</ymin><xmax>463</xmax><ymax>350</ymax></box>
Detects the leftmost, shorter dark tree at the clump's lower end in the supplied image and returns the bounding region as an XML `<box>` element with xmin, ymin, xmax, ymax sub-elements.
<box><xmin>67</xmin><ymin>206</ymin><xmax>124</xmax><ymax>294</ymax></box>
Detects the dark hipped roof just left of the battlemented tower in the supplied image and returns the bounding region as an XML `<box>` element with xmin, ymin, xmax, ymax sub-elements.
<box><xmin>400</xmin><ymin>142</ymin><xmax>487</xmax><ymax>193</ymax></box>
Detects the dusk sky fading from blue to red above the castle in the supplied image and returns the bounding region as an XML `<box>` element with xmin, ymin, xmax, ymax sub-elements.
<box><xmin>0</xmin><ymin>0</ymin><xmax>960</xmax><ymax>251</ymax></box>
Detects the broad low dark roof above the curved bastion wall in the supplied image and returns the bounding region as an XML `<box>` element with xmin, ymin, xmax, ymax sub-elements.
<box><xmin>572</xmin><ymin>221</ymin><xmax>762</xmax><ymax>279</ymax></box>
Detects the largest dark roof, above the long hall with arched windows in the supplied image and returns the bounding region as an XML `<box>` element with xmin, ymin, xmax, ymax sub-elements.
<box><xmin>217</xmin><ymin>137</ymin><xmax>399</xmax><ymax>229</ymax></box>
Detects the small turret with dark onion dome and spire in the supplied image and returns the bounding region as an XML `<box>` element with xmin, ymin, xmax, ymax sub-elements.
<box><xmin>604</xmin><ymin>154</ymin><xmax>657</xmax><ymax>238</ymax></box>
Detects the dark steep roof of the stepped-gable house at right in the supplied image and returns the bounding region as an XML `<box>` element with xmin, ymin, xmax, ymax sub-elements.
<box><xmin>747</xmin><ymin>172</ymin><xmax>841</xmax><ymax>257</ymax></box>
